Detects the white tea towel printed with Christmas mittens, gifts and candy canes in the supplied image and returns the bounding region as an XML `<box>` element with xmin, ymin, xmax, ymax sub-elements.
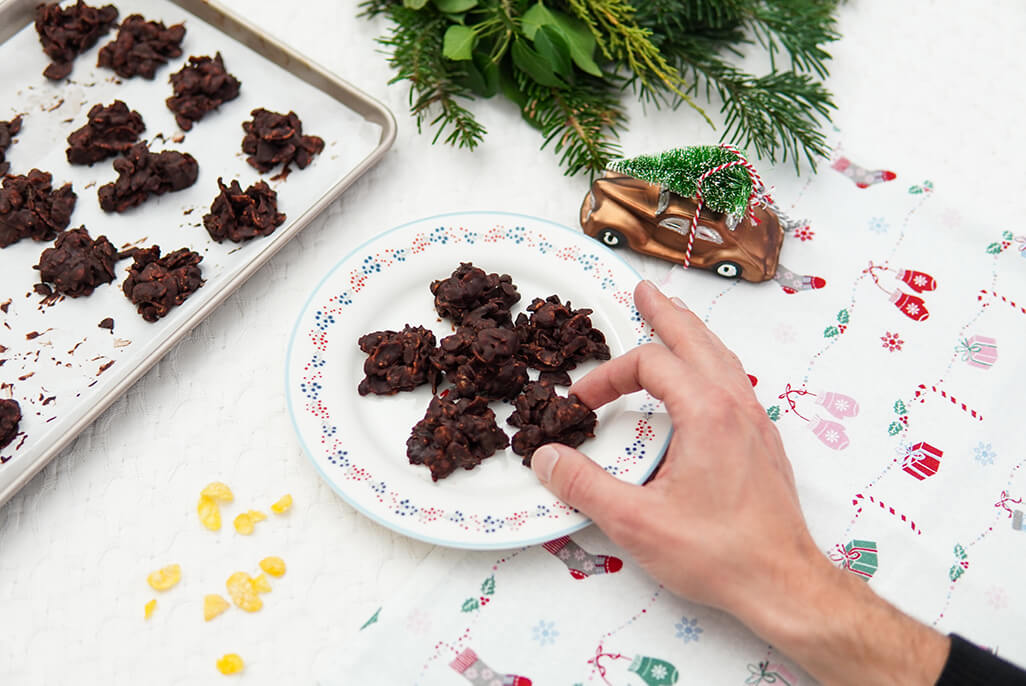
<box><xmin>320</xmin><ymin>153</ymin><xmax>1026</xmax><ymax>686</ymax></box>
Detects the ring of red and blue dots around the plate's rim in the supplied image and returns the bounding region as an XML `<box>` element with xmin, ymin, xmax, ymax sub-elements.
<box><xmin>299</xmin><ymin>225</ymin><xmax>658</xmax><ymax>534</ymax></box>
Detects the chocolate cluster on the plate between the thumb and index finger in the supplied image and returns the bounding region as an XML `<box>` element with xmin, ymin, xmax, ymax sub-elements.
<box><xmin>506</xmin><ymin>382</ymin><xmax>598</xmax><ymax>467</ymax></box>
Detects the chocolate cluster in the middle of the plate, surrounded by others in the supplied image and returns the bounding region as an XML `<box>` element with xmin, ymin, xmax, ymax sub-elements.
<box><xmin>433</xmin><ymin>326</ymin><xmax>527</xmax><ymax>400</ymax></box>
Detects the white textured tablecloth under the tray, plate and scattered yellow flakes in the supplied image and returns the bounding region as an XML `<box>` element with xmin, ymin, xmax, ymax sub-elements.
<box><xmin>0</xmin><ymin>0</ymin><xmax>1026</xmax><ymax>684</ymax></box>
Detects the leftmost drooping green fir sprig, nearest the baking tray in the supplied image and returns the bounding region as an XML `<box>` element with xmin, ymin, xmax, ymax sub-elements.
<box><xmin>379</xmin><ymin>5</ymin><xmax>485</xmax><ymax>150</ymax></box>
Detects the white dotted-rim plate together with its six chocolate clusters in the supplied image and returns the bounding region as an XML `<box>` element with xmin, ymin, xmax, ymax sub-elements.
<box><xmin>286</xmin><ymin>212</ymin><xmax>670</xmax><ymax>549</ymax></box>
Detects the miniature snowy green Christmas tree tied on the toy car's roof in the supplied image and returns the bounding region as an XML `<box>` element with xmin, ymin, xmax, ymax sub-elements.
<box><xmin>607</xmin><ymin>146</ymin><xmax>752</xmax><ymax>214</ymax></box>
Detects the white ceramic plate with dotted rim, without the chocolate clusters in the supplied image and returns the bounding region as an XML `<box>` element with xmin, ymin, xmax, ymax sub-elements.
<box><xmin>286</xmin><ymin>212</ymin><xmax>670</xmax><ymax>549</ymax></box>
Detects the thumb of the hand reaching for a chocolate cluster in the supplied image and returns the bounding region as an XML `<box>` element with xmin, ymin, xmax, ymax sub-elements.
<box><xmin>530</xmin><ymin>443</ymin><xmax>637</xmax><ymax>526</ymax></box>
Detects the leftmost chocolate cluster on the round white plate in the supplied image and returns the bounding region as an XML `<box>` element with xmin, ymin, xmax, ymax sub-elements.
<box><xmin>357</xmin><ymin>324</ymin><xmax>439</xmax><ymax>396</ymax></box>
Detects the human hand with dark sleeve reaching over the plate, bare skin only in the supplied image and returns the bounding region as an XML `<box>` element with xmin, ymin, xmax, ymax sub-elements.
<box><xmin>531</xmin><ymin>282</ymin><xmax>947</xmax><ymax>684</ymax></box>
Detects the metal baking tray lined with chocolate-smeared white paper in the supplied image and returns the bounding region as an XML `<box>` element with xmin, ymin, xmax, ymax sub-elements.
<box><xmin>0</xmin><ymin>0</ymin><xmax>396</xmax><ymax>503</ymax></box>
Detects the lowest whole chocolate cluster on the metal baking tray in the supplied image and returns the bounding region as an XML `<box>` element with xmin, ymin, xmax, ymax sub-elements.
<box><xmin>122</xmin><ymin>245</ymin><xmax>203</xmax><ymax>322</ymax></box>
